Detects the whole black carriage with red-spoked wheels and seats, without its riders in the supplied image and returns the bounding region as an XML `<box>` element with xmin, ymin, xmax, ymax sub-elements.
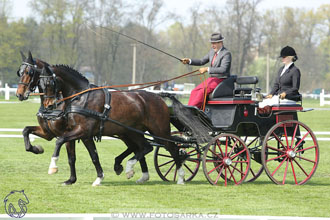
<box><xmin>154</xmin><ymin>76</ymin><xmax>319</xmax><ymax>185</ymax></box>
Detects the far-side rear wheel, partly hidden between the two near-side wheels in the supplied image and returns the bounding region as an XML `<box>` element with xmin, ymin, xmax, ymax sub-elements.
<box><xmin>240</xmin><ymin>136</ymin><xmax>264</xmax><ymax>182</ymax></box>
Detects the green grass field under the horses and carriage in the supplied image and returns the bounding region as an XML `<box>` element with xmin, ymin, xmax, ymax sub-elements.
<box><xmin>0</xmin><ymin>100</ymin><xmax>330</xmax><ymax>217</ymax></box>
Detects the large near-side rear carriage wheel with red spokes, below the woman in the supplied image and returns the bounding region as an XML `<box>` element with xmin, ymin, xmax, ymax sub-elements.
<box><xmin>261</xmin><ymin>120</ymin><xmax>319</xmax><ymax>185</ymax></box>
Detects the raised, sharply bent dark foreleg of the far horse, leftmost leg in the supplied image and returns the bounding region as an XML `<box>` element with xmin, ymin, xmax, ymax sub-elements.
<box><xmin>23</xmin><ymin>126</ymin><xmax>54</xmax><ymax>154</ymax></box>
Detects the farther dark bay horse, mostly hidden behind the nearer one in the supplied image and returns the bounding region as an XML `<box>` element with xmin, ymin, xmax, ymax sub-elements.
<box><xmin>16</xmin><ymin>52</ymin><xmax>149</xmax><ymax>185</ymax></box>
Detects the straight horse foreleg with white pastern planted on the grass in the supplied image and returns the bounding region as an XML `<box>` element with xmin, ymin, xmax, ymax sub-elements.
<box><xmin>82</xmin><ymin>139</ymin><xmax>104</xmax><ymax>186</ymax></box>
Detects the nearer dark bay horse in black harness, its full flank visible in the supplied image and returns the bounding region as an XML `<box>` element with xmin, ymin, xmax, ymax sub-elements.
<box><xmin>41</xmin><ymin>65</ymin><xmax>184</xmax><ymax>184</ymax></box>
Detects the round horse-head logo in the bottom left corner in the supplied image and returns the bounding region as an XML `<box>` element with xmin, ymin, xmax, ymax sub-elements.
<box><xmin>4</xmin><ymin>190</ymin><xmax>29</xmax><ymax>218</ymax></box>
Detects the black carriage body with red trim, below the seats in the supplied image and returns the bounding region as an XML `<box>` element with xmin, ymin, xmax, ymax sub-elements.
<box><xmin>205</xmin><ymin>98</ymin><xmax>301</xmax><ymax>136</ymax></box>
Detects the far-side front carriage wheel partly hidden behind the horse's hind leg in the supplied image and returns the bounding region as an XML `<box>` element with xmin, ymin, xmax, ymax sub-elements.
<box><xmin>154</xmin><ymin>132</ymin><xmax>201</xmax><ymax>182</ymax></box>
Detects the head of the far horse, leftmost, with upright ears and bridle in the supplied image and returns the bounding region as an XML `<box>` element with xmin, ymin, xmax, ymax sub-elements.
<box><xmin>16</xmin><ymin>51</ymin><xmax>45</xmax><ymax>101</ymax></box>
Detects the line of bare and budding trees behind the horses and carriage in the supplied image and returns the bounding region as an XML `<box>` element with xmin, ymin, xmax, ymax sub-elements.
<box><xmin>0</xmin><ymin>0</ymin><xmax>330</xmax><ymax>92</ymax></box>
